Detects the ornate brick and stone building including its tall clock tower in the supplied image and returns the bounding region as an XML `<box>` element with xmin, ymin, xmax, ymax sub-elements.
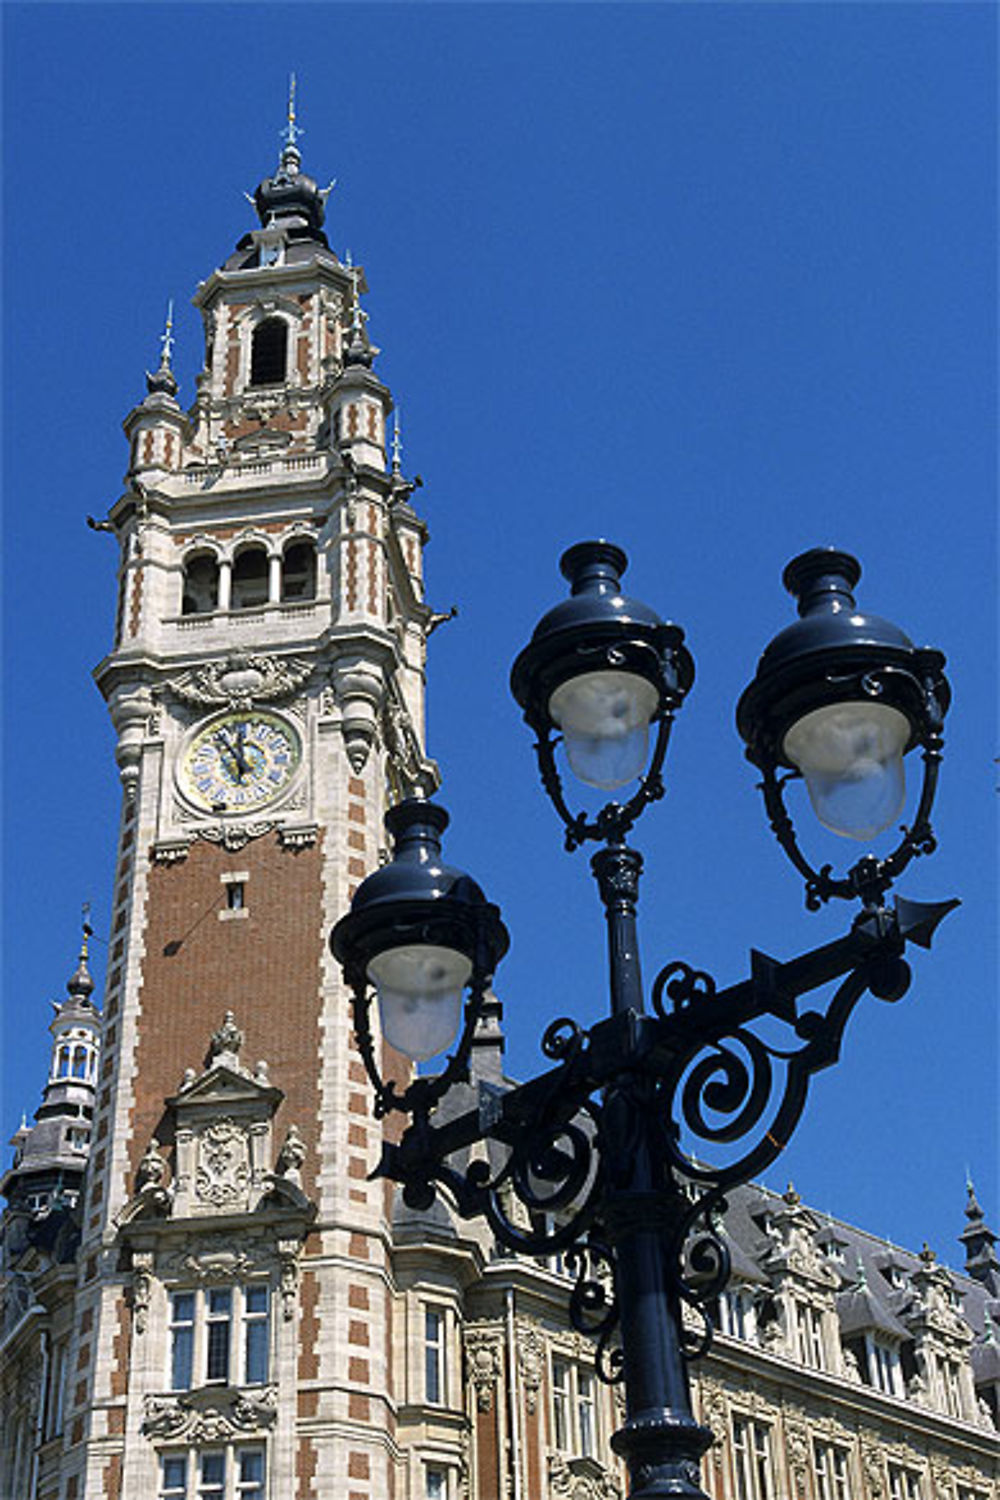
<box><xmin>1</xmin><ymin>126</ymin><xmax>1000</xmax><ymax>1500</ymax></box>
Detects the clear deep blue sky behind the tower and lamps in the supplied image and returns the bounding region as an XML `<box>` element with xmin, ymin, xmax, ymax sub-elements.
<box><xmin>3</xmin><ymin>3</ymin><xmax>1000</xmax><ymax>1263</ymax></box>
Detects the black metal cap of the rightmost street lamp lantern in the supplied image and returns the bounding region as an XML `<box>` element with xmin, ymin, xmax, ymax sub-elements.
<box><xmin>736</xmin><ymin>548</ymin><xmax>951</xmax><ymax>765</ymax></box>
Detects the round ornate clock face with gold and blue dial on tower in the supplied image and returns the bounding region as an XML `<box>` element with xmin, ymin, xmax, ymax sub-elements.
<box><xmin>180</xmin><ymin>710</ymin><xmax>301</xmax><ymax>813</ymax></box>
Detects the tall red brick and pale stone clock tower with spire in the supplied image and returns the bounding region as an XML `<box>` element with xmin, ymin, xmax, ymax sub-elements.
<box><xmin>73</xmin><ymin>108</ymin><xmax>435</xmax><ymax>1500</ymax></box>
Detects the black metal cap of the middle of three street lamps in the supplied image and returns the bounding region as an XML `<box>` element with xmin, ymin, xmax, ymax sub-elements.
<box><xmin>510</xmin><ymin>540</ymin><xmax>694</xmax><ymax>722</ymax></box>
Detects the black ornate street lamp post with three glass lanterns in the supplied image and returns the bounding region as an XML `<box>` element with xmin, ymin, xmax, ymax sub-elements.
<box><xmin>331</xmin><ymin>542</ymin><xmax>957</xmax><ymax>1500</ymax></box>
